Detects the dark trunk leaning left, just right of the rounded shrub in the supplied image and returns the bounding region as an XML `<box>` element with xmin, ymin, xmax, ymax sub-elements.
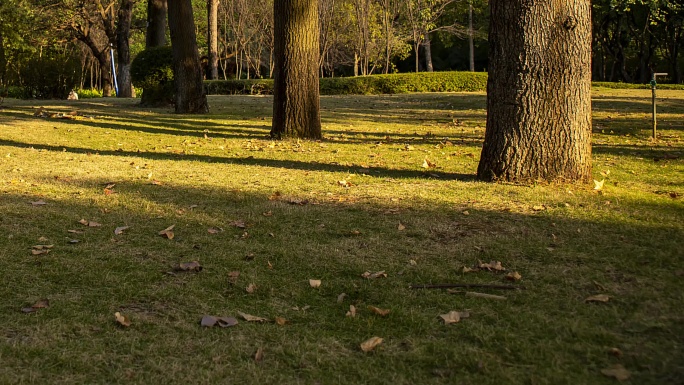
<box><xmin>169</xmin><ymin>0</ymin><xmax>209</xmax><ymax>114</ymax></box>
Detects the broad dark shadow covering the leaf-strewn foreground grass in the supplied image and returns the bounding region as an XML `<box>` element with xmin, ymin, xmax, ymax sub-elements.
<box><xmin>0</xmin><ymin>175</ymin><xmax>684</xmax><ymax>384</ymax></box>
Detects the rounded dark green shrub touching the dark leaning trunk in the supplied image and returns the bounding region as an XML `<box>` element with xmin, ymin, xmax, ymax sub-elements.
<box><xmin>131</xmin><ymin>46</ymin><xmax>174</xmax><ymax>107</ymax></box>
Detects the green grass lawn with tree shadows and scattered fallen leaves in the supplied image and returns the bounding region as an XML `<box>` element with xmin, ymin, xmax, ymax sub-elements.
<box><xmin>0</xmin><ymin>89</ymin><xmax>684</xmax><ymax>385</ymax></box>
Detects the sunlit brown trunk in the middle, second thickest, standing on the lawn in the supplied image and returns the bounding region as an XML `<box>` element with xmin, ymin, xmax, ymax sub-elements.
<box><xmin>271</xmin><ymin>0</ymin><xmax>321</xmax><ymax>139</ymax></box>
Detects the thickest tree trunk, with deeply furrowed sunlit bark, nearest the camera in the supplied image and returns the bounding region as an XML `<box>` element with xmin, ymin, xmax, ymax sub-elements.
<box><xmin>477</xmin><ymin>0</ymin><xmax>591</xmax><ymax>181</ymax></box>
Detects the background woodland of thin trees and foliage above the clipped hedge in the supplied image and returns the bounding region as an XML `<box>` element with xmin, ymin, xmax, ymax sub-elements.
<box><xmin>0</xmin><ymin>0</ymin><xmax>684</xmax><ymax>96</ymax></box>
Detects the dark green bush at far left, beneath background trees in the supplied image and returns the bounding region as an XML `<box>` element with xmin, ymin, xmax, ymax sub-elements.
<box><xmin>20</xmin><ymin>52</ymin><xmax>81</xmax><ymax>99</ymax></box>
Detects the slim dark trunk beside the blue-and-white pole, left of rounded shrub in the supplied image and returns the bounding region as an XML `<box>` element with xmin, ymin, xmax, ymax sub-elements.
<box><xmin>116</xmin><ymin>0</ymin><xmax>135</xmax><ymax>98</ymax></box>
